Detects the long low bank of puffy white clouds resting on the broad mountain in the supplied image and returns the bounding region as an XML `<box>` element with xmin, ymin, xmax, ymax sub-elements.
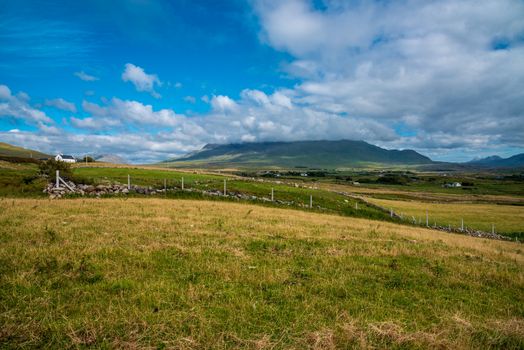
<box><xmin>71</xmin><ymin>90</ymin><xmax>395</xmax><ymax>153</ymax></box>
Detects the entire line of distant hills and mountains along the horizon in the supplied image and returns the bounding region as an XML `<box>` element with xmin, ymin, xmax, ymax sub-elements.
<box><xmin>0</xmin><ymin>140</ymin><xmax>524</xmax><ymax>171</ymax></box>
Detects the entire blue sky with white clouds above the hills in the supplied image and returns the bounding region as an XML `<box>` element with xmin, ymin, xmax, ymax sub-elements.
<box><xmin>0</xmin><ymin>0</ymin><xmax>524</xmax><ymax>162</ymax></box>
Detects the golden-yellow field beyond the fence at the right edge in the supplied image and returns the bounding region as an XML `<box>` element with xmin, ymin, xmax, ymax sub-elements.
<box><xmin>367</xmin><ymin>198</ymin><xmax>524</xmax><ymax>238</ymax></box>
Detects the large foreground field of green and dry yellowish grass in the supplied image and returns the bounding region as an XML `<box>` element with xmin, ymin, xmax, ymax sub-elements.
<box><xmin>0</xmin><ymin>198</ymin><xmax>524</xmax><ymax>349</ymax></box>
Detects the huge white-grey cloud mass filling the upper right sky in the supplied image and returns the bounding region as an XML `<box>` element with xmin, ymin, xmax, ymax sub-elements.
<box><xmin>254</xmin><ymin>0</ymin><xmax>524</xmax><ymax>150</ymax></box>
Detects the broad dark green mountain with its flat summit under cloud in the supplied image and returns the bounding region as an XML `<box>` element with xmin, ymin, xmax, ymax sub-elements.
<box><xmin>165</xmin><ymin>140</ymin><xmax>433</xmax><ymax>168</ymax></box>
